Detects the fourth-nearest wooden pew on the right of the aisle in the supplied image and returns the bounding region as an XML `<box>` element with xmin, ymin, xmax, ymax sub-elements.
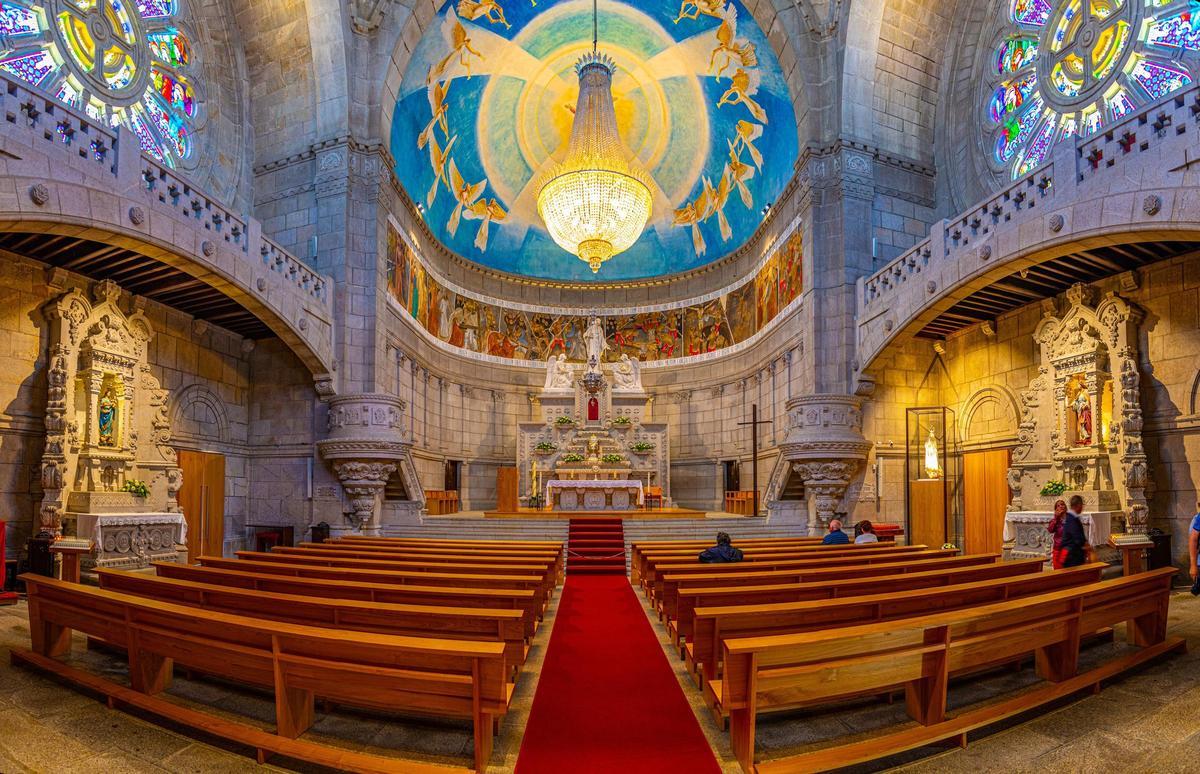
<box><xmin>661</xmin><ymin>550</ymin><xmax>1000</xmax><ymax>619</ymax></box>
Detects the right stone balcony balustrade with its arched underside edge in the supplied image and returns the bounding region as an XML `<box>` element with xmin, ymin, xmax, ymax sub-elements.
<box><xmin>856</xmin><ymin>88</ymin><xmax>1200</xmax><ymax>374</ymax></box>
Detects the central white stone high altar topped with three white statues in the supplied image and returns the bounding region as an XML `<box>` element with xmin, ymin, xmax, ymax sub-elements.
<box><xmin>517</xmin><ymin>318</ymin><xmax>671</xmax><ymax>511</ymax></box>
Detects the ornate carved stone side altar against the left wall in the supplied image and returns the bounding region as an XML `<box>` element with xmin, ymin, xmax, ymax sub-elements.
<box><xmin>36</xmin><ymin>281</ymin><xmax>187</xmax><ymax>570</ymax></box>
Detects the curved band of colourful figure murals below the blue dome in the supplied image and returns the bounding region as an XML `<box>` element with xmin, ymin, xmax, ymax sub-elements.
<box><xmin>385</xmin><ymin>220</ymin><xmax>804</xmax><ymax>362</ymax></box>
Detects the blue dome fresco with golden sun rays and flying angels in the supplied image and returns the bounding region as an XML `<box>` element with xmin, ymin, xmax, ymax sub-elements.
<box><xmin>391</xmin><ymin>0</ymin><xmax>798</xmax><ymax>282</ymax></box>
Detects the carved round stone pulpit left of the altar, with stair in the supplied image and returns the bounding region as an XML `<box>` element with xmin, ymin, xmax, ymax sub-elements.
<box><xmin>317</xmin><ymin>392</ymin><xmax>425</xmax><ymax>534</ymax></box>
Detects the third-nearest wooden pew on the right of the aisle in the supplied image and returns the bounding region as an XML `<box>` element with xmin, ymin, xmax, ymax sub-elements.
<box><xmin>667</xmin><ymin>554</ymin><xmax>1045</xmax><ymax>646</ymax></box>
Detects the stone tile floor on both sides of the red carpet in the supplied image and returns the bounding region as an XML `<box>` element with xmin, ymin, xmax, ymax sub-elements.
<box><xmin>0</xmin><ymin>583</ymin><xmax>1200</xmax><ymax>774</ymax></box>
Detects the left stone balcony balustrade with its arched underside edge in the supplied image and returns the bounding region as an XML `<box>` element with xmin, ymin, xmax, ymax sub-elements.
<box><xmin>0</xmin><ymin>73</ymin><xmax>334</xmax><ymax>383</ymax></box>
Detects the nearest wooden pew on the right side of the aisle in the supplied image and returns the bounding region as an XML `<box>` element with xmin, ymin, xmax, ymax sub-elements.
<box><xmin>706</xmin><ymin>568</ymin><xmax>1186</xmax><ymax>774</ymax></box>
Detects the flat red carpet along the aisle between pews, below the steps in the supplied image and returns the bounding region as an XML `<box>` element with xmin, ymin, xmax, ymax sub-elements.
<box><xmin>516</xmin><ymin>574</ymin><xmax>720</xmax><ymax>774</ymax></box>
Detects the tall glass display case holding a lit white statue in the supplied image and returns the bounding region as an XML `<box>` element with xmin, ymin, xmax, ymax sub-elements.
<box><xmin>905</xmin><ymin>406</ymin><xmax>962</xmax><ymax>548</ymax></box>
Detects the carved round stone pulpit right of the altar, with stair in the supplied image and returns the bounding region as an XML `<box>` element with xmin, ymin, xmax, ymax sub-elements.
<box><xmin>767</xmin><ymin>395</ymin><xmax>871</xmax><ymax>534</ymax></box>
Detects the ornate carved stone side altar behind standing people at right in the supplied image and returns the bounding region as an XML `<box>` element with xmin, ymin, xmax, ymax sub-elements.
<box><xmin>1004</xmin><ymin>284</ymin><xmax>1150</xmax><ymax>559</ymax></box>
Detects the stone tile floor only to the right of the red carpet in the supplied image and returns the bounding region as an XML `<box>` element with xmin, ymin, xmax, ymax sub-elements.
<box><xmin>638</xmin><ymin>583</ymin><xmax>1200</xmax><ymax>774</ymax></box>
